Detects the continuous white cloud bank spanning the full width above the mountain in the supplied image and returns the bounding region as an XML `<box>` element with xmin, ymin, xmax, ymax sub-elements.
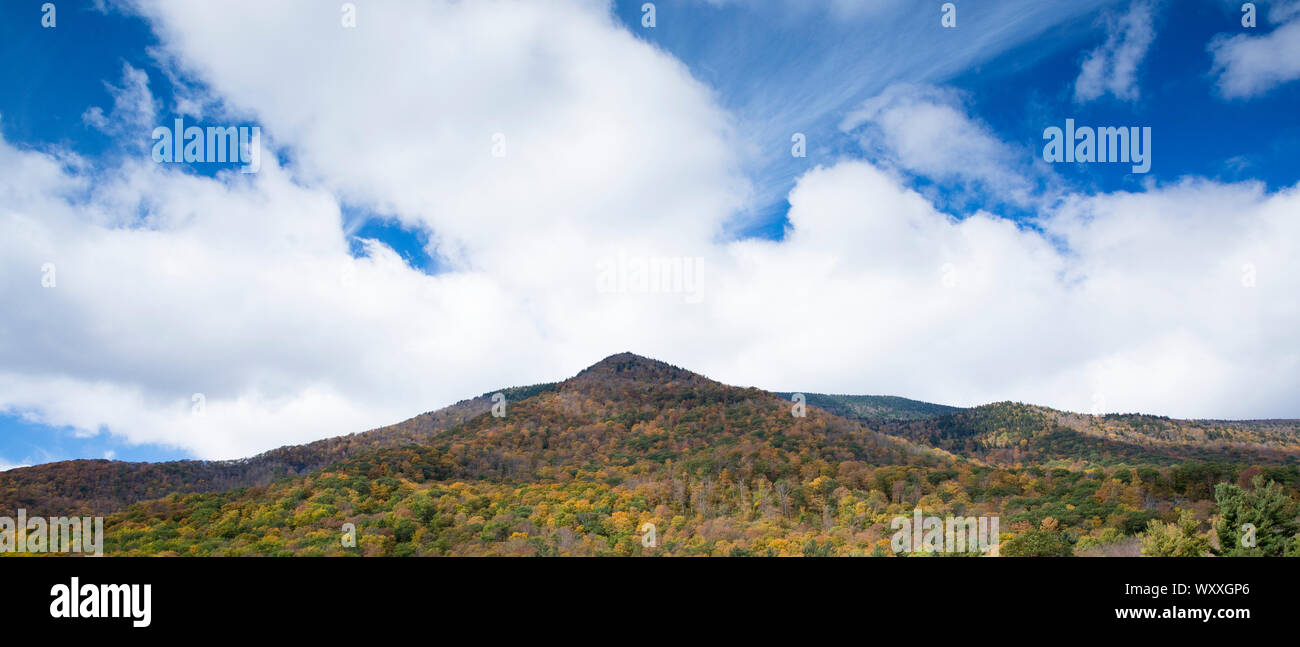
<box><xmin>0</xmin><ymin>3</ymin><xmax>1300</xmax><ymax>457</ymax></box>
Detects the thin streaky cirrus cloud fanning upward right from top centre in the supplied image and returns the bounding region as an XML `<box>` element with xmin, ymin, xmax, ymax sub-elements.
<box><xmin>660</xmin><ymin>0</ymin><xmax>1118</xmax><ymax>229</ymax></box>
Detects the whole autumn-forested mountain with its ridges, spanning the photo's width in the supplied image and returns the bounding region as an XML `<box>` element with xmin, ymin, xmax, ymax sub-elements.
<box><xmin>0</xmin><ymin>353</ymin><xmax>1300</xmax><ymax>556</ymax></box>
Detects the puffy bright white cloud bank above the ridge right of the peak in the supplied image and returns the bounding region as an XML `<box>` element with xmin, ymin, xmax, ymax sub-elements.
<box><xmin>719</xmin><ymin>161</ymin><xmax>1300</xmax><ymax>417</ymax></box>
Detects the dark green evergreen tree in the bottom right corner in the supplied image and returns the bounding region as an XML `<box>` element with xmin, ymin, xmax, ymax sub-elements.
<box><xmin>1214</xmin><ymin>476</ymin><xmax>1300</xmax><ymax>557</ymax></box>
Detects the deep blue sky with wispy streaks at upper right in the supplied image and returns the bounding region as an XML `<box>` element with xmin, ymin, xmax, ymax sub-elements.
<box><xmin>618</xmin><ymin>1</ymin><xmax>1300</xmax><ymax>236</ymax></box>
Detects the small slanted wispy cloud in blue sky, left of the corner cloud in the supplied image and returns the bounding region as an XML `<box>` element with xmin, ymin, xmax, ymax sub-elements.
<box><xmin>1074</xmin><ymin>0</ymin><xmax>1156</xmax><ymax>103</ymax></box>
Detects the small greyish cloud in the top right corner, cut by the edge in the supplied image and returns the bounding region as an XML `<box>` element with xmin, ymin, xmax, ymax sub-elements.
<box><xmin>1209</xmin><ymin>3</ymin><xmax>1300</xmax><ymax>99</ymax></box>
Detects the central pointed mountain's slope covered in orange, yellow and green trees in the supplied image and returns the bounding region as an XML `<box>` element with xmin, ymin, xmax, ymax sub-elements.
<box><xmin>107</xmin><ymin>356</ymin><xmax>972</xmax><ymax>555</ymax></box>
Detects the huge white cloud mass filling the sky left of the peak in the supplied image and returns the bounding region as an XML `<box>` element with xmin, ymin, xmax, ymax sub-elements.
<box><xmin>0</xmin><ymin>3</ymin><xmax>746</xmax><ymax>457</ymax></box>
